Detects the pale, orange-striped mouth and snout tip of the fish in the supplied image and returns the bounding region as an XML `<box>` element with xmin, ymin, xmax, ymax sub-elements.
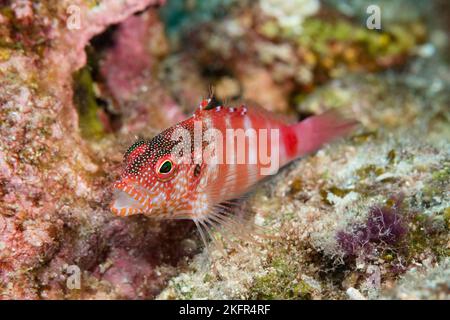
<box><xmin>110</xmin><ymin>181</ymin><xmax>151</xmax><ymax>217</ymax></box>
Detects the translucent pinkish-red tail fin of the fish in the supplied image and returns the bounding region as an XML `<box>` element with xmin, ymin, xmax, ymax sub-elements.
<box><xmin>290</xmin><ymin>111</ymin><xmax>358</xmax><ymax>157</ymax></box>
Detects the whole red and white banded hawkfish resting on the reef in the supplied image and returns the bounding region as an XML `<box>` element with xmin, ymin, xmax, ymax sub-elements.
<box><xmin>111</xmin><ymin>99</ymin><xmax>355</xmax><ymax>245</ymax></box>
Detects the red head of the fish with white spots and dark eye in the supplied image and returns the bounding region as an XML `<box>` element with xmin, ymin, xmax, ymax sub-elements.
<box><xmin>110</xmin><ymin>130</ymin><xmax>198</xmax><ymax>218</ymax></box>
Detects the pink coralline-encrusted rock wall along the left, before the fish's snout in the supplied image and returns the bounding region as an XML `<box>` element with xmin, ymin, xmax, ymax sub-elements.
<box><xmin>0</xmin><ymin>0</ymin><xmax>190</xmax><ymax>299</ymax></box>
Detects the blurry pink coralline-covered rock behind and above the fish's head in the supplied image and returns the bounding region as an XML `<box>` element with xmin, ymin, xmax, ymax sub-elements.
<box><xmin>100</xmin><ymin>11</ymin><xmax>184</xmax><ymax>132</ymax></box>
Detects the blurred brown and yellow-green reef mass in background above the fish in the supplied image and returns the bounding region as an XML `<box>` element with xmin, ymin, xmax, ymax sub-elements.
<box><xmin>159</xmin><ymin>0</ymin><xmax>426</xmax><ymax>112</ymax></box>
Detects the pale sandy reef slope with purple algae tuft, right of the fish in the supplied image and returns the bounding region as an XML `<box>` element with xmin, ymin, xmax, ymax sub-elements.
<box><xmin>156</xmin><ymin>65</ymin><xmax>450</xmax><ymax>299</ymax></box>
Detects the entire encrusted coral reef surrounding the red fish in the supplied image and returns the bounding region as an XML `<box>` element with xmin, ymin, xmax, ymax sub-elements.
<box><xmin>0</xmin><ymin>0</ymin><xmax>450</xmax><ymax>299</ymax></box>
